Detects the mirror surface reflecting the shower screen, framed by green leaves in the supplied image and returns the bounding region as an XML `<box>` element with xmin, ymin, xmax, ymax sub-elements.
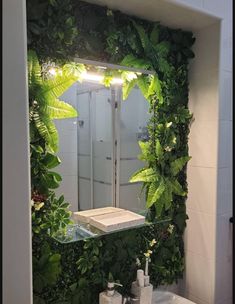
<box><xmin>56</xmin><ymin>82</ymin><xmax>149</xmax><ymax>211</ymax></box>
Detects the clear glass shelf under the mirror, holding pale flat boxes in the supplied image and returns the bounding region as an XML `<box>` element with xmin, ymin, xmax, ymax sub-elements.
<box><xmin>53</xmin><ymin>212</ymin><xmax>171</xmax><ymax>244</ymax></box>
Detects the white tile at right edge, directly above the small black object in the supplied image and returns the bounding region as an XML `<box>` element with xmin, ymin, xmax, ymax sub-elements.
<box><xmin>216</xmin><ymin>166</ymin><xmax>233</xmax><ymax>215</ymax></box>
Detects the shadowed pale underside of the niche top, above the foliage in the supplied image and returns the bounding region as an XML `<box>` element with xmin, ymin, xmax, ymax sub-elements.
<box><xmin>85</xmin><ymin>0</ymin><xmax>219</xmax><ymax>31</ymax></box>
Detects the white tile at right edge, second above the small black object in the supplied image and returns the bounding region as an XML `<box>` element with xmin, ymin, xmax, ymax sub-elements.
<box><xmin>218</xmin><ymin>120</ymin><xmax>233</xmax><ymax>168</ymax></box>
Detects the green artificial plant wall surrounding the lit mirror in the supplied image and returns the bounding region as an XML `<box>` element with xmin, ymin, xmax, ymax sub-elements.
<box><xmin>27</xmin><ymin>0</ymin><xmax>194</xmax><ymax>304</ymax></box>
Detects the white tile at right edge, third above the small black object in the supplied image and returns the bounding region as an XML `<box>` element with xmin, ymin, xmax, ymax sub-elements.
<box><xmin>219</xmin><ymin>70</ymin><xmax>233</xmax><ymax>120</ymax></box>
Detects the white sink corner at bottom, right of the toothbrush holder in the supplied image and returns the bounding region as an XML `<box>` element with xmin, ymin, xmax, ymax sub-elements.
<box><xmin>152</xmin><ymin>290</ymin><xmax>196</xmax><ymax>304</ymax></box>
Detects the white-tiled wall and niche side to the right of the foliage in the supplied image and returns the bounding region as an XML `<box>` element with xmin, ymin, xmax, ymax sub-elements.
<box><xmin>169</xmin><ymin>0</ymin><xmax>232</xmax><ymax>304</ymax></box>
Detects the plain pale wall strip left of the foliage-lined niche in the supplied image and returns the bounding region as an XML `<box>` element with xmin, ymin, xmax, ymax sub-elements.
<box><xmin>2</xmin><ymin>0</ymin><xmax>32</xmax><ymax>304</ymax></box>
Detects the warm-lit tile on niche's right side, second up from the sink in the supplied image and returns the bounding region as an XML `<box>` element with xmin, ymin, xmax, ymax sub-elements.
<box><xmin>184</xmin><ymin>208</ymin><xmax>215</xmax><ymax>259</ymax></box>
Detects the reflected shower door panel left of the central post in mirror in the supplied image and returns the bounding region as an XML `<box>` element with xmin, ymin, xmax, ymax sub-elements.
<box><xmin>77</xmin><ymin>86</ymin><xmax>114</xmax><ymax>210</ymax></box>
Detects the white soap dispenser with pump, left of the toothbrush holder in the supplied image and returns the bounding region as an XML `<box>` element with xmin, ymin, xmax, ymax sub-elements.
<box><xmin>99</xmin><ymin>282</ymin><xmax>122</xmax><ymax>304</ymax></box>
